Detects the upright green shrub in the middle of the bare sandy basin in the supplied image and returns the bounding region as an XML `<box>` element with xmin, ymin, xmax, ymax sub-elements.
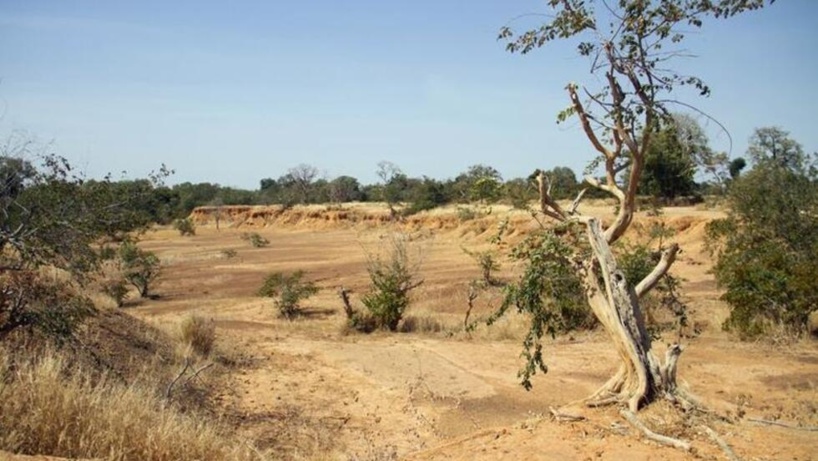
<box><xmin>361</xmin><ymin>236</ymin><xmax>423</xmax><ymax>331</ymax></box>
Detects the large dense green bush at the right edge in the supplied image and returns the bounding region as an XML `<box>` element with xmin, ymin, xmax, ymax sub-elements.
<box><xmin>707</xmin><ymin>129</ymin><xmax>818</xmax><ymax>338</ymax></box>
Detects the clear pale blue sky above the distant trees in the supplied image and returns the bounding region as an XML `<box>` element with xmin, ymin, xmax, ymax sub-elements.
<box><xmin>0</xmin><ymin>0</ymin><xmax>818</xmax><ymax>189</ymax></box>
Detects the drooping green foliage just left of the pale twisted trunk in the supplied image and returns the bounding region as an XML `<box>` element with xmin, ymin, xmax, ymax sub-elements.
<box><xmin>488</xmin><ymin>224</ymin><xmax>596</xmax><ymax>389</ymax></box>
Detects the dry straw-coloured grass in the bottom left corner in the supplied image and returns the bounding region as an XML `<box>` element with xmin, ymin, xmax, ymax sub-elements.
<box><xmin>0</xmin><ymin>350</ymin><xmax>258</xmax><ymax>460</ymax></box>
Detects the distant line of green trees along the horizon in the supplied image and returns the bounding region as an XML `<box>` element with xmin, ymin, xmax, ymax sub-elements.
<box><xmin>124</xmin><ymin>114</ymin><xmax>747</xmax><ymax>223</ymax></box>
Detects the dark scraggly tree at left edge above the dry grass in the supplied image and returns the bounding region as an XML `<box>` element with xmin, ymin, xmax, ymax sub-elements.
<box><xmin>0</xmin><ymin>134</ymin><xmax>168</xmax><ymax>337</ymax></box>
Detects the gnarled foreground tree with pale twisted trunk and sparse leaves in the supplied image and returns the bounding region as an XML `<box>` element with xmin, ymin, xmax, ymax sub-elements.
<box><xmin>500</xmin><ymin>0</ymin><xmax>765</xmax><ymax>411</ymax></box>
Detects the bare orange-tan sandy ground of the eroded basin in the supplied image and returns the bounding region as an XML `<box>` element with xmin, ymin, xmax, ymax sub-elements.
<box><xmin>129</xmin><ymin>208</ymin><xmax>818</xmax><ymax>460</ymax></box>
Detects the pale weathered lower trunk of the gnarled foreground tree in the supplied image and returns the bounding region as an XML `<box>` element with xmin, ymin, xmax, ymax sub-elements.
<box><xmin>583</xmin><ymin>218</ymin><xmax>681</xmax><ymax>412</ymax></box>
